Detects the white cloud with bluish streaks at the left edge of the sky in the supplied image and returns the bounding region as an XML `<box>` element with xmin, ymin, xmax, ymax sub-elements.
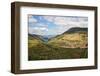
<box><xmin>28</xmin><ymin>15</ymin><xmax>48</xmax><ymax>35</ymax></box>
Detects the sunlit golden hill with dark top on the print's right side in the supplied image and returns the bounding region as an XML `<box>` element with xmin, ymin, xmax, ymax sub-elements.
<box><xmin>48</xmin><ymin>27</ymin><xmax>88</xmax><ymax>48</ymax></box>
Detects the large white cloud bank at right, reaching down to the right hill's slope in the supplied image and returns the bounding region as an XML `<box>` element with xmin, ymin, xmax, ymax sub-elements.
<box><xmin>44</xmin><ymin>16</ymin><xmax>88</xmax><ymax>34</ymax></box>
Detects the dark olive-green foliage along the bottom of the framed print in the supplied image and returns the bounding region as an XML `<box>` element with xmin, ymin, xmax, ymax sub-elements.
<box><xmin>28</xmin><ymin>40</ymin><xmax>87</xmax><ymax>60</ymax></box>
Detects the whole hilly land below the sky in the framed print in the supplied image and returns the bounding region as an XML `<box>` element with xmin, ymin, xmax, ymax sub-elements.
<box><xmin>28</xmin><ymin>28</ymin><xmax>88</xmax><ymax>60</ymax></box>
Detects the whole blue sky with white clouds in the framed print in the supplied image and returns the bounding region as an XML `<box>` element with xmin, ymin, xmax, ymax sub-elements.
<box><xmin>28</xmin><ymin>15</ymin><xmax>88</xmax><ymax>35</ymax></box>
